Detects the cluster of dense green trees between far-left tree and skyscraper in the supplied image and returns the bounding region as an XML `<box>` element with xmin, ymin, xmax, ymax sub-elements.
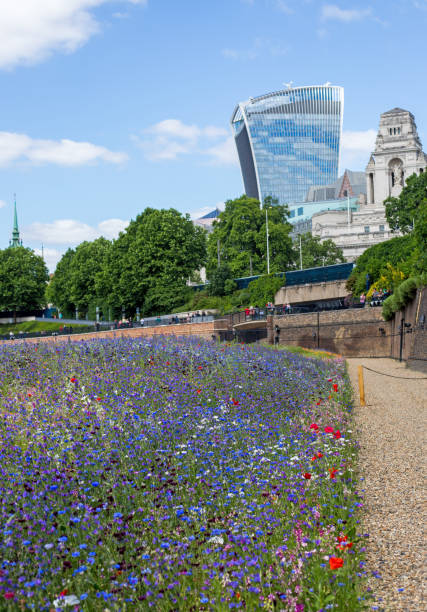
<box><xmin>48</xmin><ymin>208</ymin><xmax>206</xmax><ymax>316</ymax></box>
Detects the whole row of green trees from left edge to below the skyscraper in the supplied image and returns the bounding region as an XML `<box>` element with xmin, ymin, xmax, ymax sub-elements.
<box><xmin>0</xmin><ymin>196</ymin><xmax>344</xmax><ymax>318</ymax></box>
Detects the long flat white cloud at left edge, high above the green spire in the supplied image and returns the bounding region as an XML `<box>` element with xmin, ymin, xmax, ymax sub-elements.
<box><xmin>0</xmin><ymin>132</ymin><xmax>127</xmax><ymax>166</ymax></box>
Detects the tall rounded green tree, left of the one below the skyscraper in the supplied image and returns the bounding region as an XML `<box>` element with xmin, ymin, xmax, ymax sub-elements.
<box><xmin>107</xmin><ymin>208</ymin><xmax>206</xmax><ymax>315</ymax></box>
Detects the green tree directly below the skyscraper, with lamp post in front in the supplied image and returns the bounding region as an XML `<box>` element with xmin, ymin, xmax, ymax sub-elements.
<box><xmin>207</xmin><ymin>195</ymin><xmax>294</xmax><ymax>279</ymax></box>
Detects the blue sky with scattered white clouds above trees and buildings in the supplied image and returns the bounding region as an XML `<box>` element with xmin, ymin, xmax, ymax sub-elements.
<box><xmin>0</xmin><ymin>0</ymin><xmax>427</xmax><ymax>269</ymax></box>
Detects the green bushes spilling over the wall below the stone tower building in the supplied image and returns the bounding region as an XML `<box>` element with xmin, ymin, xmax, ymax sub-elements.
<box><xmin>347</xmin><ymin>234</ymin><xmax>418</xmax><ymax>296</ymax></box>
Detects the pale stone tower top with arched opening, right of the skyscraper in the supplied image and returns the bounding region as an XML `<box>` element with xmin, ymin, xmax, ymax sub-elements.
<box><xmin>366</xmin><ymin>108</ymin><xmax>427</xmax><ymax>205</ymax></box>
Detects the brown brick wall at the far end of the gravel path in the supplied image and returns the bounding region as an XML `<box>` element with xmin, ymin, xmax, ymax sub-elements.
<box><xmin>268</xmin><ymin>307</ymin><xmax>391</xmax><ymax>357</ymax></box>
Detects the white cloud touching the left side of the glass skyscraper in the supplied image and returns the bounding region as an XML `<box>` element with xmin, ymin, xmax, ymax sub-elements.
<box><xmin>133</xmin><ymin>119</ymin><xmax>234</xmax><ymax>164</ymax></box>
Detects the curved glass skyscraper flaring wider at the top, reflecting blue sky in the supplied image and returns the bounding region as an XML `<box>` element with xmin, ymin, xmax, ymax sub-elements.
<box><xmin>231</xmin><ymin>84</ymin><xmax>344</xmax><ymax>204</ymax></box>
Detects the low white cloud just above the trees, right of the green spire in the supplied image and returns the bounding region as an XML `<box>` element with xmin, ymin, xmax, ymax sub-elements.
<box><xmin>22</xmin><ymin>219</ymin><xmax>129</xmax><ymax>246</ymax></box>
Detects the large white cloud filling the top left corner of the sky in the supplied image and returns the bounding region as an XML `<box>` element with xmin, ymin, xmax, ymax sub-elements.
<box><xmin>0</xmin><ymin>0</ymin><xmax>147</xmax><ymax>69</ymax></box>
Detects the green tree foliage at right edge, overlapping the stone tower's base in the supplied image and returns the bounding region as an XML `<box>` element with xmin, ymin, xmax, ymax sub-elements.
<box><xmin>384</xmin><ymin>172</ymin><xmax>427</xmax><ymax>234</ymax></box>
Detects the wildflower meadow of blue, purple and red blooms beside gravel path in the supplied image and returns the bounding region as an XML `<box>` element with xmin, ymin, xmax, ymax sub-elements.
<box><xmin>0</xmin><ymin>337</ymin><xmax>365</xmax><ymax>612</ymax></box>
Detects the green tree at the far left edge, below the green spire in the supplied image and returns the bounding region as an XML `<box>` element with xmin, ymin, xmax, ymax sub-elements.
<box><xmin>0</xmin><ymin>247</ymin><xmax>49</xmax><ymax>323</ymax></box>
